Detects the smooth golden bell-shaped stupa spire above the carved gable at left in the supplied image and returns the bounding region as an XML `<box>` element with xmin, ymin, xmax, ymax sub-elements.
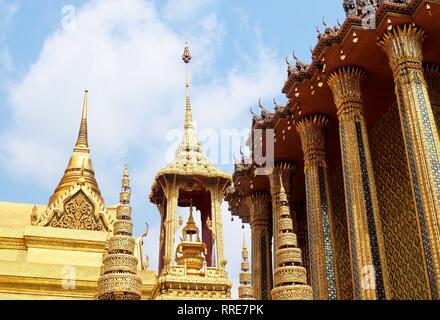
<box><xmin>48</xmin><ymin>90</ymin><xmax>102</xmax><ymax>206</ymax></box>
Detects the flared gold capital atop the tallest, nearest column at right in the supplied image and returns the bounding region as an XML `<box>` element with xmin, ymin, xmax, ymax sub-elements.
<box><xmin>379</xmin><ymin>24</ymin><xmax>426</xmax><ymax>73</ymax></box>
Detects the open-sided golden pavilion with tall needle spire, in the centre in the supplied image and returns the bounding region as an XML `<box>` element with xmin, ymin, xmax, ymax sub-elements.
<box><xmin>150</xmin><ymin>46</ymin><xmax>232</xmax><ymax>299</ymax></box>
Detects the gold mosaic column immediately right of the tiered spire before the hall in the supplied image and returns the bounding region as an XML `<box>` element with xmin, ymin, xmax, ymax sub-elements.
<box><xmin>297</xmin><ymin>115</ymin><xmax>337</xmax><ymax>300</ymax></box>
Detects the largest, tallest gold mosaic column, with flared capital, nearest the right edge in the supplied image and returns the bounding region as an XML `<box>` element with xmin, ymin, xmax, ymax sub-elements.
<box><xmin>381</xmin><ymin>25</ymin><xmax>440</xmax><ymax>299</ymax></box>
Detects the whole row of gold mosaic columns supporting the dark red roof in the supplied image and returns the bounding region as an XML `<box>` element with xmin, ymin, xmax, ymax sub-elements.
<box><xmin>245</xmin><ymin>25</ymin><xmax>440</xmax><ymax>299</ymax></box>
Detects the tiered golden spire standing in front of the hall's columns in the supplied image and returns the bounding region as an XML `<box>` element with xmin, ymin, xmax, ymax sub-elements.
<box><xmin>270</xmin><ymin>167</ymin><xmax>313</xmax><ymax>300</ymax></box>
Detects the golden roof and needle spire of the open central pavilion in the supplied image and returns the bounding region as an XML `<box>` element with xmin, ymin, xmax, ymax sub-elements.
<box><xmin>150</xmin><ymin>45</ymin><xmax>232</xmax><ymax>202</ymax></box>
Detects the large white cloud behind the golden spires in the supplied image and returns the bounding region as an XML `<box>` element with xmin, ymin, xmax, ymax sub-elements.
<box><xmin>0</xmin><ymin>0</ymin><xmax>284</xmax><ymax>296</ymax></box>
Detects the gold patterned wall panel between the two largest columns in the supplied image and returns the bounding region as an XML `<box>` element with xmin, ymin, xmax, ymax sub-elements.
<box><xmin>369</xmin><ymin>105</ymin><xmax>430</xmax><ymax>299</ymax></box>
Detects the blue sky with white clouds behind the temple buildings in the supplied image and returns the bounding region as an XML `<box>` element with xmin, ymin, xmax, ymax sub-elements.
<box><xmin>0</xmin><ymin>0</ymin><xmax>344</xmax><ymax>294</ymax></box>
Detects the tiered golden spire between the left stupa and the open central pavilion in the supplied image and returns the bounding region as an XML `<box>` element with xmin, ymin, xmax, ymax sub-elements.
<box><xmin>97</xmin><ymin>164</ymin><xmax>142</xmax><ymax>300</ymax></box>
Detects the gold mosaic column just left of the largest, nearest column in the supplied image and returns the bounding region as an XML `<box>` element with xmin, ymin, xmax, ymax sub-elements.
<box><xmin>328</xmin><ymin>67</ymin><xmax>389</xmax><ymax>299</ymax></box>
